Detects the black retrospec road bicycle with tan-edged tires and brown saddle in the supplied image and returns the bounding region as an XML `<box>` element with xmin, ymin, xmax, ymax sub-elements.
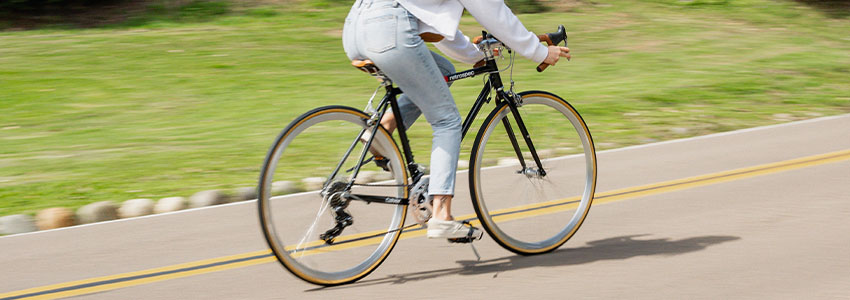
<box><xmin>258</xmin><ymin>25</ymin><xmax>596</xmax><ymax>286</ymax></box>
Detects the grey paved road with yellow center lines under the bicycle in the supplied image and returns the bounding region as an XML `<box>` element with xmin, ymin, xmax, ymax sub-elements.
<box><xmin>0</xmin><ymin>115</ymin><xmax>850</xmax><ymax>299</ymax></box>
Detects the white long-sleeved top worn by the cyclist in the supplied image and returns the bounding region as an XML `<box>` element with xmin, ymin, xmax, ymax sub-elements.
<box><xmin>398</xmin><ymin>0</ymin><xmax>549</xmax><ymax>64</ymax></box>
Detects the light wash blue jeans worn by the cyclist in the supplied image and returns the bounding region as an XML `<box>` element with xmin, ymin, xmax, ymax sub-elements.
<box><xmin>342</xmin><ymin>0</ymin><xmax>461</xmax><ymax>195</ymax></box>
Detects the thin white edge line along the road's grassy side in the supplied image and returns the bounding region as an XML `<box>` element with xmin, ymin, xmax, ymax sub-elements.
<box><xmin>0</xmin><ymin>114</ymin><xmax>850</xmax><ymax>240</ymax></box>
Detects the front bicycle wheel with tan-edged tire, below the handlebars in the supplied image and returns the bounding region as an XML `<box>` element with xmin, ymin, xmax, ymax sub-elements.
<box><xmin>469</xmin><ymin>91</ymin><xmax>596</xmax><ymax>255</ymax></box>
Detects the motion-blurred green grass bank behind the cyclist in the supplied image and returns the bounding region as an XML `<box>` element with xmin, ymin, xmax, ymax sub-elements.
<box><xmin>0</xmin><ymin>0</ymin><xmax>850</xmax><ymax>215</ymax></box>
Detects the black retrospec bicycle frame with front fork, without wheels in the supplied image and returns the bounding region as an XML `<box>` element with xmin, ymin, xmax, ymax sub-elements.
<box><xmin>348</xmin><ymin>55</ymin><xmax>546</xmax><ymax>205</ymax></box>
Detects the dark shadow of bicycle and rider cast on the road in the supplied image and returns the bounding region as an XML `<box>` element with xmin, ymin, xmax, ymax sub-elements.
<box><xmin>307</xmin><ymin>234</ymin><xmax>740</xmax><ymax>291</ymax></box>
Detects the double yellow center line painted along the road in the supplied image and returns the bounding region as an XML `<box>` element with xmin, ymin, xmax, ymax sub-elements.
<box><xmin>0</xmin><ymin>149</ymin><xmax>850</xmax><ymax>300</ymax></box>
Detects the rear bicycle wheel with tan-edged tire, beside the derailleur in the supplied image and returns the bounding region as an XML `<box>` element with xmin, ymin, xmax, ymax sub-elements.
<box><xmin>258</xmin><ymin>106</ymin><xmax>407</xmax><ymax>286</ymax></box>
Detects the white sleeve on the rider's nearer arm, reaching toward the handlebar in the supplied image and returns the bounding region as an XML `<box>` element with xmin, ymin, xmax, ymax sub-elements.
<box><xmin>458</xmin><ymin>0</ymin><xmax>549</xmax><ymax>63</ymax></box>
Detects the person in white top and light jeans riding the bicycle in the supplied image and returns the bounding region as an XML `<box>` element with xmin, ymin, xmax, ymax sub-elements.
<box><xmin>342</xmin><ymin>0</ymin><xmax>569</xmax><ymax>239</ymax></box>
